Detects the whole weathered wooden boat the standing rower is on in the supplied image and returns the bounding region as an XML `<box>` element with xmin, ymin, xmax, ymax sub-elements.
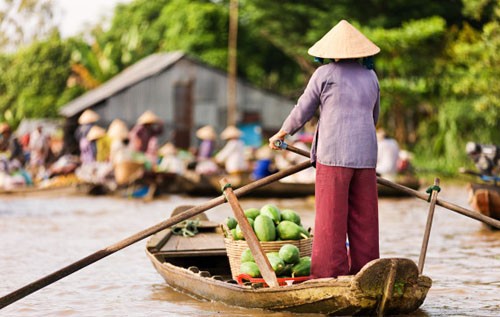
<box><xmin>146</xmin><ymin>207</ymin><xmax>432</xmax><ymax>315</ymax></box>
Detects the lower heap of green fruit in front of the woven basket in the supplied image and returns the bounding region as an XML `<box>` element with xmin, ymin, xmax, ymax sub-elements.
<box><xmin>240</xmin><ymin>244</ymin><xmax>311</xmax><ymax>277</ymax></box>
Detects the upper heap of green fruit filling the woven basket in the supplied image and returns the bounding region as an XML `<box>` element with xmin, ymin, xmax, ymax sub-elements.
<box><xmin>226</xmin><ymin>204</ymin><xmax>310</xmax><ymax>241</ymax></box>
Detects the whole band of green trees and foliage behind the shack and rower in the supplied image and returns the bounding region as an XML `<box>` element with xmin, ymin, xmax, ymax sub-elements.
<box><xmin>0</xmin><ymin>0</ymin><xmax>500</xmax><ymax>175</ymax></box>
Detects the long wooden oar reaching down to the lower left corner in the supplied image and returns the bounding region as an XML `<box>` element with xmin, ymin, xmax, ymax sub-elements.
<box><xmin>0</xmin><ymin>162</ymin><xmax>311</xmax><ymax>309</ymax></box>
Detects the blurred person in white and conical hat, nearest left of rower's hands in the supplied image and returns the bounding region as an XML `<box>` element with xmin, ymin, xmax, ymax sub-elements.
<box><xmin>215</xmin><ymin>126</ymin><xmax>249</xmax><ymax>174</ymax></box>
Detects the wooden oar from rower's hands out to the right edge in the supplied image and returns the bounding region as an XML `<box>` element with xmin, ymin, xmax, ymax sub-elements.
<box><xmin>275</xmin><ymin>141</ymin><xmax>500</xmax><ymax>229</ymax></box>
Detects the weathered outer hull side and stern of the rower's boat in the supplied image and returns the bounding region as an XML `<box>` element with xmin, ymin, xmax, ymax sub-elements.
<box><xmin>147</xmin><ymin>251</ymin><xmax>432</xmax><ymax>315</ymax></box>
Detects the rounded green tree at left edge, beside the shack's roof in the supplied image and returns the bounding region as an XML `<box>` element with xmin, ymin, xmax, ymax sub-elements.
<box><xmin>0</xmin><ymin>33</ymin><xmax>71</xmax><ymax>125</ymax></box>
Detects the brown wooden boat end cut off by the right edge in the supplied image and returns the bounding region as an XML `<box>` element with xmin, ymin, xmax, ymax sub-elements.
<box><xmin>467</xmin><ymin>183</ymin><xmax>500</xmax><ymax>228</ymax></box>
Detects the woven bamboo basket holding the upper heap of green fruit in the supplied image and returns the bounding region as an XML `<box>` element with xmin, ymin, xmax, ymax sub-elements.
<box><xmin>224</xmin><ymin>238</ymin><xmax>313</xmax><ymax>279</ymax></box>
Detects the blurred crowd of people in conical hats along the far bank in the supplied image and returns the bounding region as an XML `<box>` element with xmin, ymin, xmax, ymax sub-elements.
<box><xmin>0</xmin><ymin>109</ymin><xmax>411</xmax><ymax>190</ymax></box>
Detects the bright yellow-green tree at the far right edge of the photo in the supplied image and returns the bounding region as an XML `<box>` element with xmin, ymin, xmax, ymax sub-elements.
<box><xmin>417</xmin><ymin>0</ymin><xmax>500</xmax><ymax>172</ymax></box>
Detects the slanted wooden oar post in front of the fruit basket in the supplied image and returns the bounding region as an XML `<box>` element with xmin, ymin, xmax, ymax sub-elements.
<box><xmin>219</xmin><ymin>178</ymin><xmax>279</xmax><ymax>287</ymax></box>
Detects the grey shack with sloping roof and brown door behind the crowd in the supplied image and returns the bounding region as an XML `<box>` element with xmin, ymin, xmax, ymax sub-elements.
<box><xmin>60</xmin><ymin>52</ymin><xmax>294</xmax><ymax>148</ymax></box>
